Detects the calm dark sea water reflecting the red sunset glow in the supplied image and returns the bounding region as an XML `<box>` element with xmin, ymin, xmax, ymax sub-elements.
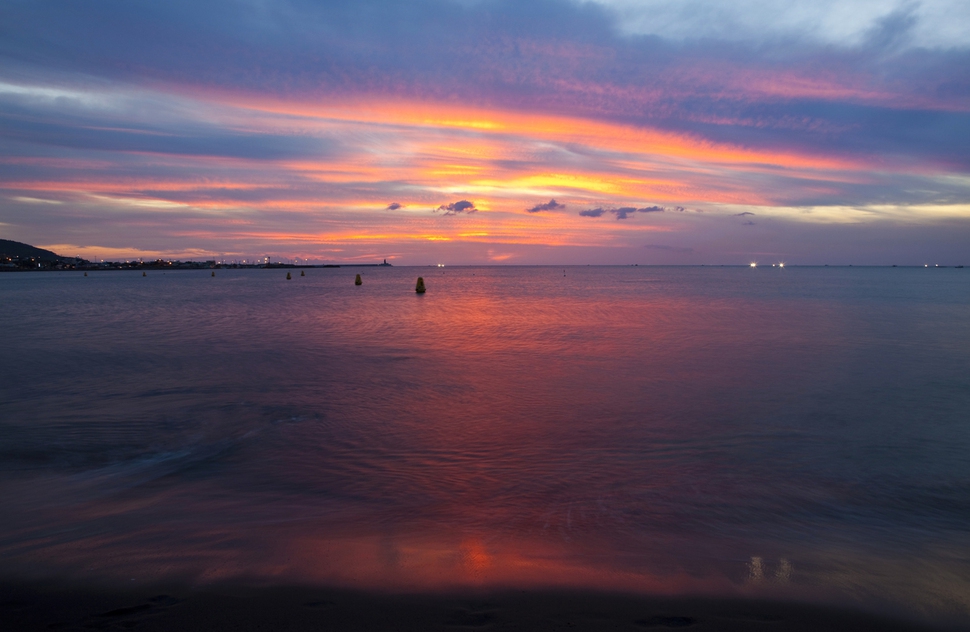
<box><xmin>0</xmin><ymin>267</ymin><xmax>970</xmax><ymax>621</ymax></box>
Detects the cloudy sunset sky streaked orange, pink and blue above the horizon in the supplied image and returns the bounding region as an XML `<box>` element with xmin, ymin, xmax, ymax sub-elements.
<box><xmin>0</xmin><ymin>0</ymin><xmax>970</xmax><ymax>265</ymax></box>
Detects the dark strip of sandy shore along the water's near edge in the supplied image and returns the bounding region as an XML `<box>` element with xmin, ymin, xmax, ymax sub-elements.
<box><xmin>0</xmin><ymin>583</ymin><xmax>959</xmax><ymax>632</ymax></box>
